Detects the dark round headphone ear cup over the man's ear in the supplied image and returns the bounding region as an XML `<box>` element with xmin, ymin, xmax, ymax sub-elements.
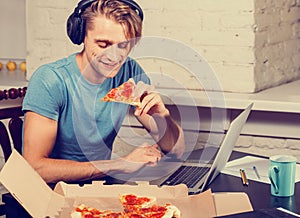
<box><xmin>67</xmin><ymin>13</ymin><xmax>85</xmax><ymax>45</ymax></box>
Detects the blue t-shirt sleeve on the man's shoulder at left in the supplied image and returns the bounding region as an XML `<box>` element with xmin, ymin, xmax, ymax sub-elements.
<box><xmin>22</xmin><ymin>66</ymin><xmax>64</xmax><ymax>120</ymax></box>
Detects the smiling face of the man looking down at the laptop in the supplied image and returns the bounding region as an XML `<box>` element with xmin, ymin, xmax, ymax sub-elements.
<box><xmin>84</xmin><ymin>16</ymin><xmax>130</xmax><ymax>78</ymax></box>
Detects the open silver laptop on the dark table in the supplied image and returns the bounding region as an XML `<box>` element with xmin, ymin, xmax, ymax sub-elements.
<box><xmin>151</xmin><ymin>103</ymin><xmax>253</xmax><ymax>194</ymax></box>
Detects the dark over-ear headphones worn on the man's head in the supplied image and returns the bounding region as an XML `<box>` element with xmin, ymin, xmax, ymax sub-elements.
<box><xmin>67</xmin><ymin>0</ymin><xmax>144</xmax><ymax>45</ymax></box>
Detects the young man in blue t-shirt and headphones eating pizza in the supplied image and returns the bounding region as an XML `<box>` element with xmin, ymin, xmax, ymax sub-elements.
<box><xmin>23</xmin><ymin>0</ymin><xmax>184</xmax><ymax>183</ymax></box>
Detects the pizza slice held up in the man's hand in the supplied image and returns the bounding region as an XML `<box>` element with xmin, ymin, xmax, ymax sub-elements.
<box><xmin>101</xmin><ymin>78</ymin><xmax>141</xmax><ymax>107</ymax></box>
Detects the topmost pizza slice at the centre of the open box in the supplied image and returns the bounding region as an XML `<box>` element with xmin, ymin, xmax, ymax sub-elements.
<box><xmin>119</xmin><ymin>194</ymin><xmax>156</xmax><ymax>212</ymax></box>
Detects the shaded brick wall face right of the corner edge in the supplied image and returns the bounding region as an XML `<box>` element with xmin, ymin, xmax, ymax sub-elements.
<box><xmin>254</xmin><ymin>0</ymin><xmax>300</xmax><ymax>90</ymax></box>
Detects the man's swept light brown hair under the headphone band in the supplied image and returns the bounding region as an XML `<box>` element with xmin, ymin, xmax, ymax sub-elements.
<box><xmin>82</xmin><ymin>0</ymin><xmax>142</xmax><ymax>43</ymax></box>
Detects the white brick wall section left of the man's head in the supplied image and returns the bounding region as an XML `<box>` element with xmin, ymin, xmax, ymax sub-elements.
<box><xmin>26</xmin><ymin>0</ymin><xmax>78</xmax><ymax>74</ymax></box>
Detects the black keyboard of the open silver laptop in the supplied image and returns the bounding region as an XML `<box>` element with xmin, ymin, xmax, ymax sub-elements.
<box><xmin>161</xmin><ymin>166</ymin><xmax>210</xmax><ymax>188</ymax></box>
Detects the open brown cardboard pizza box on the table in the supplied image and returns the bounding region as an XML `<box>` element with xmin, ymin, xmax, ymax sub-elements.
<box><xmin>0</xmin><ymin>150</ymin><xmax>252</xmax><ymax>218</ymax></box>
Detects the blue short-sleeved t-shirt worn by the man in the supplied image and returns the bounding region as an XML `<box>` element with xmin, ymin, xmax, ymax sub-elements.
<box><xmin>23</xmin><ymin>54</ymin><xmax>150</xmax><ymax>161</ymax></box>
